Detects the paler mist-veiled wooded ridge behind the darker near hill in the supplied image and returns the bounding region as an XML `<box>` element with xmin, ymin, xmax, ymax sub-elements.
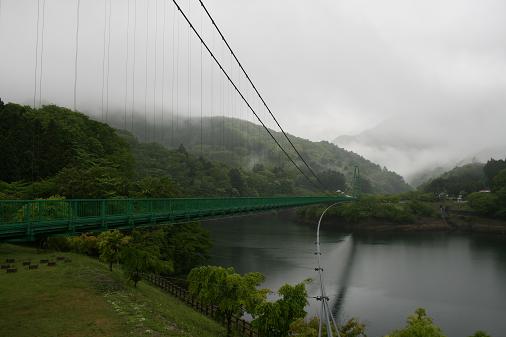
<box><xmin>107</xmin><ymin>116</ymin><xmax>411</xmax><ymax>193</ymax></box>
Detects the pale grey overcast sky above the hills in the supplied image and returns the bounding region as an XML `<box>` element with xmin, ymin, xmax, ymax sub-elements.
<box><xmin>0</xmin><ymin>0</ymin><xmax>506</xmax><ymax>175</ymax></box>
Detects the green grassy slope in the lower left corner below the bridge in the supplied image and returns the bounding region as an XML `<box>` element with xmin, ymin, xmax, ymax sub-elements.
<box><xmin>0</xmin><ymin>244</ymin><xmax>226</xmax><ymax>337</ymax></box>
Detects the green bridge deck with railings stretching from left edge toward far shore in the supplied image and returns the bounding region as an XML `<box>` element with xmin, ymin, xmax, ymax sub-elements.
<box><xmin>0</xmin><ymin>195</ymin><xmax>353</xmax><ymax>241</ymax></box>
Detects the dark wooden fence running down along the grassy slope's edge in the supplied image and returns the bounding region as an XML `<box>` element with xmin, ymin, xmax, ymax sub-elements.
<box><xmin>144</xmin><ymin>274</ymin><xmax>258</xmax><ymax>337</ymax></box>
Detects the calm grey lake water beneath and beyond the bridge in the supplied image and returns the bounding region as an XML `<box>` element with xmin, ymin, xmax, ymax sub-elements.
<box><xmin>204</xmin><ymin>214</ymin><xmax>506</xmax><ymax>337</ymax></box>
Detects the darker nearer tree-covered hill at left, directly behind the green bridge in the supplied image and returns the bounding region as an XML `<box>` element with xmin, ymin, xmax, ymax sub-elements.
<box><xmin>0</xmin><ymin>104</ymin><xmax>346</xmax><ymax>199</ymax></box>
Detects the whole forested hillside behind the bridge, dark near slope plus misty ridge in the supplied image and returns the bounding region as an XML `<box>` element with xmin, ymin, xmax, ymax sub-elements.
<box><xmin>0</xmin><ymin>104</ymin><xmax>408</xmax><ymax>198</ymax></box>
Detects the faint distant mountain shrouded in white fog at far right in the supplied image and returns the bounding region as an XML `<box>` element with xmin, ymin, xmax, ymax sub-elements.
<box><xmin>333</xmin><ymin>112</ymin><xmax>506</xmax><ymax>186</ymax></box>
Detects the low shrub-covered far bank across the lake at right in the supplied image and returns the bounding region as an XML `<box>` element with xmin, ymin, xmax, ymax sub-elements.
<box><xmin>295</xmin><ymin>196</ymin><xmax>506</xmax><ymax>235</ymax></box>
